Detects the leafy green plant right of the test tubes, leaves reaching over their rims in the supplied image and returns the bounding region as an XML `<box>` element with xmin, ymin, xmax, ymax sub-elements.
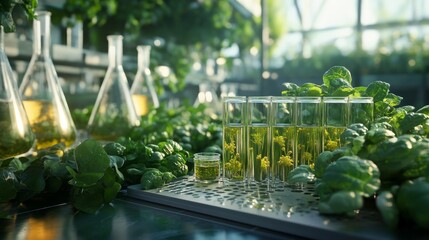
<box><xmin>283</xmin><ymin>64</ymin><xmax>429</xmax><ymax>229</ymax></box>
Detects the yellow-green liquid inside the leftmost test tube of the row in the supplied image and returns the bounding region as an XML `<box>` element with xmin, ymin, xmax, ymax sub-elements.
<box><xmin>223</xmin><ymin>125</ymin><xmax>246</xmax><ymax>180</ymax></box>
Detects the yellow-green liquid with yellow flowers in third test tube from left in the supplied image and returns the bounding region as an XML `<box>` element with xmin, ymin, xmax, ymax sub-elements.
<box><xmin>272</xmin><ymin>126</ymin><xmax>296</xmax><ymax>181</ymax></box>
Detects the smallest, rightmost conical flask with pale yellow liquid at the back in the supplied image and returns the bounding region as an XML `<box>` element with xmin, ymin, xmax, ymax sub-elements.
<box><xmin>131</xmin><ymin>45</ymin><xmax>159</xmax><ymax>116</ymax></box>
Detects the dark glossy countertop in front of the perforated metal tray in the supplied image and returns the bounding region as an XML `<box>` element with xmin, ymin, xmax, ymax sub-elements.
<box><xmin>0</xmin><ymin>194</ymin><xmax>299</xmax><ymax>240</ymax></box>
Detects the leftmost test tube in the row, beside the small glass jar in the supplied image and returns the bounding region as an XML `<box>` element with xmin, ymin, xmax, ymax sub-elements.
<box><xmin>222</xmin><ymin>96</ymin><xmax>247</xmax><ymax>181</ymax></box>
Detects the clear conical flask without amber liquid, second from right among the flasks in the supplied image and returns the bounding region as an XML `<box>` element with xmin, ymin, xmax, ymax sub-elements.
<box><xmin>88</xmin><ymin>35</ymin><xmax>139</xmax><ymax>141</ymax></box>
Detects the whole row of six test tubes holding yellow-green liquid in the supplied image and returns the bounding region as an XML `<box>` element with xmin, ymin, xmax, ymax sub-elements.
<box><xmin>222</xmin><ymin>96</ymin><xmax>374</xmax><ymax>184</ymax></box>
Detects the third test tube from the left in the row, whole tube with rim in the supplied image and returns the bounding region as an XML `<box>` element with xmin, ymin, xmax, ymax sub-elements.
<box><xmin>271</xmin><ymin>96</ymin><xmax>296</xmax><ymax>182</ymax></box>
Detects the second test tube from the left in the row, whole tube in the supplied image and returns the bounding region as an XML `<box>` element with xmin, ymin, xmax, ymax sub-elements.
<box><xmin>247</xmin><ymin>97</ymin><xmax>272</xmax><ymax>182</ymax></box>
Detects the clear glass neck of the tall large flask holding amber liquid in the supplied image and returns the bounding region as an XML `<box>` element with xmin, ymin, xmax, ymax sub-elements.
<box><xmin>33</xmin><ymin>11</ymin><xmax>51</xmax><ymax>56</ymax></box>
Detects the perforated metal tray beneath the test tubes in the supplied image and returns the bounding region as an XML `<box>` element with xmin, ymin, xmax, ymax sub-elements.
<box><xmin>128</xmin><ymin>177</ymin><xmax>397</xmax><ymax>239</ymax></box>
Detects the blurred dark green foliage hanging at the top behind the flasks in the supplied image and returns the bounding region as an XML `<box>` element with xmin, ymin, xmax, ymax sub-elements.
<box><xmin>50</xmin><ymin>0</ymin><xmax>260</xmax><ymax>87</ymax></box>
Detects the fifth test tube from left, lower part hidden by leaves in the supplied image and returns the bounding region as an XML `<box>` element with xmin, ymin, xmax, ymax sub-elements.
<box><xmin>322</xmin><ymin>97</ymin><xmax>348</xmax><ymax>151</ymax></box>
